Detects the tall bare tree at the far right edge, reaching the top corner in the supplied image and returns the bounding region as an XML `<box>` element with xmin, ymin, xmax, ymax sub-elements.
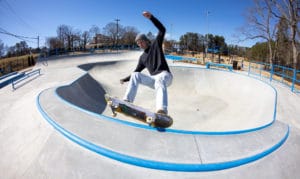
<box><xmin>271</xmin><ymin>0</ymin><xmax>300</xmax><ymax>69</ymax></box>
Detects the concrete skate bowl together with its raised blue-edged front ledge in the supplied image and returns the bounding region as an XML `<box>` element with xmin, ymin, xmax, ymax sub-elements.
<box><xmin>37</xmin><ymin>61</ymin><xmax>289</xmax><ymax>172</ymax></box>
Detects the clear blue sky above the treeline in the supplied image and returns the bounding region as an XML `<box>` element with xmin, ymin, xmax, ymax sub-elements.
<box><xmin>0</xmin><ymin>0</ymin><xmax>255</xmax><ymax>47</ymax></box>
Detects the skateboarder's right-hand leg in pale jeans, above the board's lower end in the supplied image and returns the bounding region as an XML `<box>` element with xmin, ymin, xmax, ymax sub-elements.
<box><xmin>154</xmin><ymin>71</ymin><xmax>173</xmax><ymax>114</ymax></box>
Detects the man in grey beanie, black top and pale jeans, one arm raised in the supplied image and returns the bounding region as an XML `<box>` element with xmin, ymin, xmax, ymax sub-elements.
<box><xmin>120</xmin><ymin>11</ymin><xmax>173</xmax><ymax>114</ymax></box>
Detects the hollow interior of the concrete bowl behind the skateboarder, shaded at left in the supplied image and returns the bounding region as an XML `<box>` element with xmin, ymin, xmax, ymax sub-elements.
<box><xmin>57</xmin><ymin>61</ymin><xmax>277</xmax><ymax>132</ymax></box>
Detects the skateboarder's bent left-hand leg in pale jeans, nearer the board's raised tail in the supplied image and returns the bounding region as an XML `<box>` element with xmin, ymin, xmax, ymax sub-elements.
<box><xmin>123</xmin><ymin>72</ymin><xmax>155</xmax><ymax>102</ymax></box>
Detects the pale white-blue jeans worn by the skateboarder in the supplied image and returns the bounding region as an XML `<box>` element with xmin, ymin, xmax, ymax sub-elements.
<box><xmin>123</xmin><ymin>71</ymin><xmax>173</xmax><ymax>112</ymax></box>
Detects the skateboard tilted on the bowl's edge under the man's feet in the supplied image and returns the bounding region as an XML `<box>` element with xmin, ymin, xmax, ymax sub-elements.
<box><xmin>104</xmin><ymin>94</ymin><xmax>173</xmax><ymax>128</ymax></box>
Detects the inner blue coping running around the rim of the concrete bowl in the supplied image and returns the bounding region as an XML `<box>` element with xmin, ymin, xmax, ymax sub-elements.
<box><xmin>55</xmin><ymin>66</ymin><xmax>277</xmax><ymax>135</ymax></box>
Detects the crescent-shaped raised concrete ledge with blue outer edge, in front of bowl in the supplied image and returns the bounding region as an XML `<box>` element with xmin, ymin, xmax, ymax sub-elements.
<box><xmin>38</xmin><ymin>89</ymin><xmax>289</xmax><ymax>172</ymax></box>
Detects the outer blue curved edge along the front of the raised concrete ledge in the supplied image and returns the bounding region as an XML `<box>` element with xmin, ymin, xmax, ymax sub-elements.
<box><xmin>36</xmin><ymin>87</ymin><xmax>289</xmax><ymax>172</ymax></box>
